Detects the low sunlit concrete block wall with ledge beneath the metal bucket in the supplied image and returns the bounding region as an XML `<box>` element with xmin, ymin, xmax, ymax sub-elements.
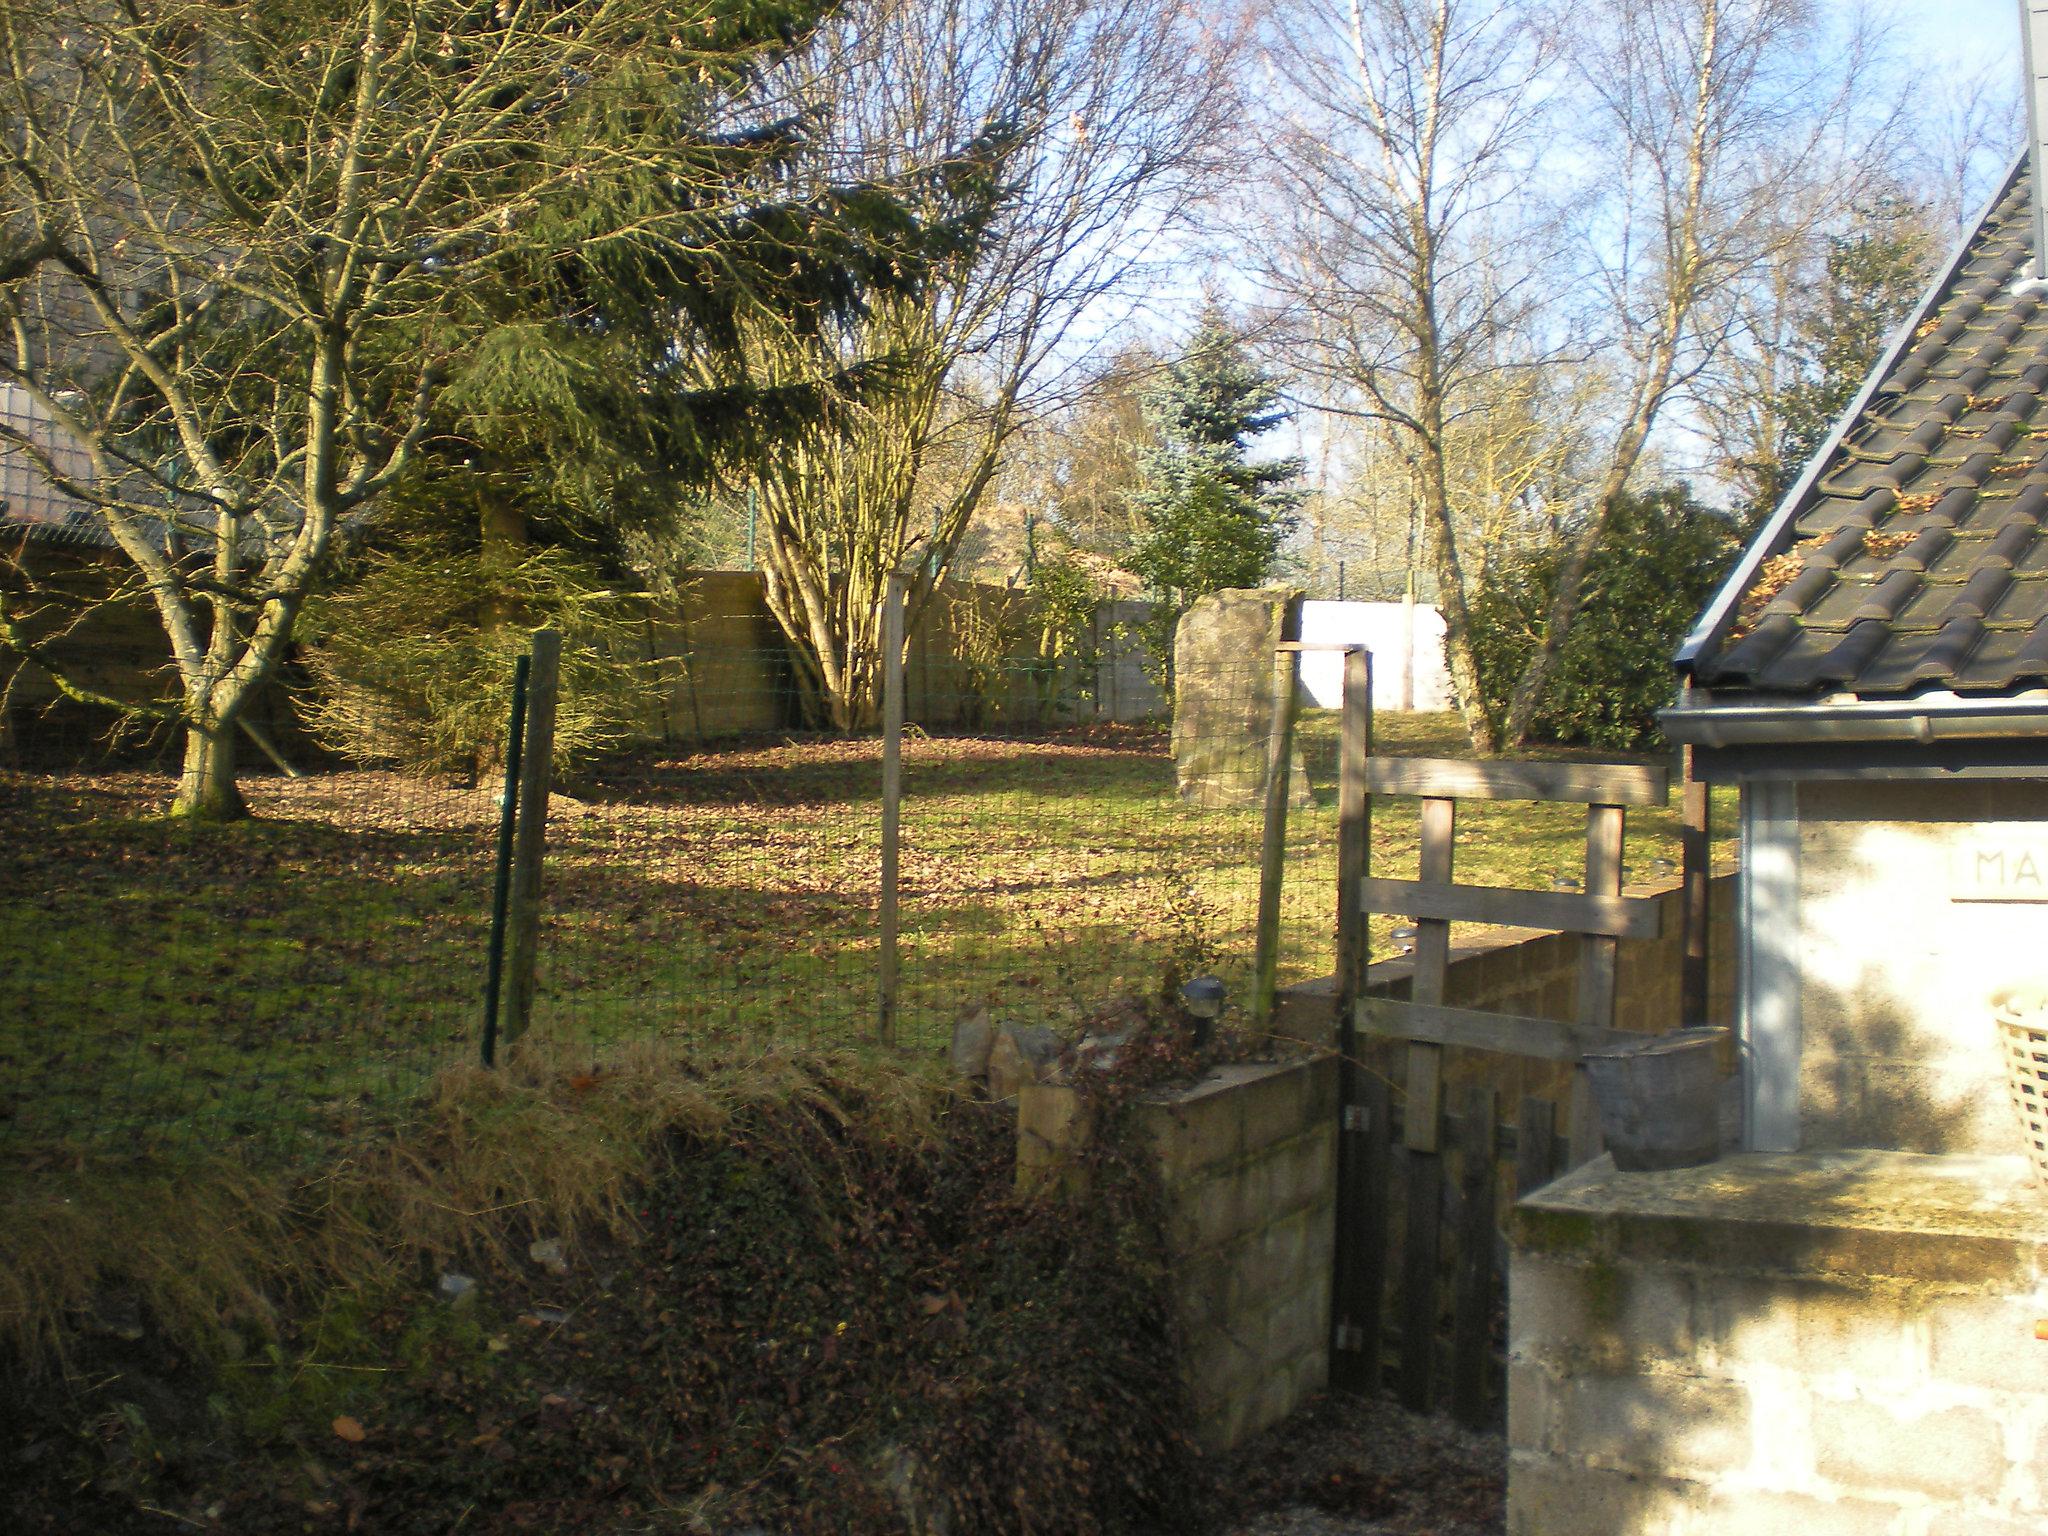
<box><xmin>1507</xmin><ymin>1155</ymin><xmax>2048</xmax><ymax>1536</ymax></box>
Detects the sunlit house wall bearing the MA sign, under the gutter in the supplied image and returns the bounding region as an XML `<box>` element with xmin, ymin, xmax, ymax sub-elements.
<box><xmin>1778</xmin><ymin>780</ymin><xmax>2048</xmax><ymax>1153</ymax></box>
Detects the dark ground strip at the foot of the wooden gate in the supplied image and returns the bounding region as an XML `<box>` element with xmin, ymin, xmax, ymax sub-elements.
<box><xmin>1223</xmin><ymin>1397</ymin><xmax>1507</xmax><ymax>1536</ymax></box>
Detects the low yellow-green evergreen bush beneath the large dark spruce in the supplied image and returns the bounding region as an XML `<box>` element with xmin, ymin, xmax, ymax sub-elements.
<box><xmin>301</xmin><ymin>547</ymin><xmax>659</xmax><ymax>774</ymax></box>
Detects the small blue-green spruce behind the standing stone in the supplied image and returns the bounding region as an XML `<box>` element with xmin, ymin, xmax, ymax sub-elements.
<box><xmin>1130</xmin><ymin>311</ymin><xmax>1303</xmax><ymax>668</ymax></box>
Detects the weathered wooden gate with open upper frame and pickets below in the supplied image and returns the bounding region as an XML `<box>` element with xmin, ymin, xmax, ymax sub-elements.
<box><xmin>1331</xmin><ymin>651</ymin><xmax>1679</xmax><ymax>1423</ymax></box>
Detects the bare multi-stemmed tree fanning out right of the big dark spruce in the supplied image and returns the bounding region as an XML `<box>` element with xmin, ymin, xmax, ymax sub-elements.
<box><xmin>756</xmin><ymin>0</ymin><xmax>1229</xmax><ymax>729</ymax></box>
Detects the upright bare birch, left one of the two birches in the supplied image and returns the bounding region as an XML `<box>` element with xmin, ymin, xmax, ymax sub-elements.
<box><xmin>1260</xmin><ymin>0</ymin><xmax>1554</xmax><ymax>750</ymax></box>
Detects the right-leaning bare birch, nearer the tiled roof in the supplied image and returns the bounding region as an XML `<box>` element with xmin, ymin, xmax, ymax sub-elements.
<box><xmin>1501</xmin><ymin>0</ymin><xmax>1896</xmax><ymax>743</ymax></box>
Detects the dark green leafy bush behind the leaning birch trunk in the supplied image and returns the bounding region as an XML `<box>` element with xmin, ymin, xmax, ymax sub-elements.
<box><xmin>1473</xmin><ymin>485</ymin><xmax>1739</xmax><ymax>752</ymax></box>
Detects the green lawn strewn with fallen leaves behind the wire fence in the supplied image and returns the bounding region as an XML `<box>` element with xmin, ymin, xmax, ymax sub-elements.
<box><xmin>0</xmin><ymin>715</ymin><xmax>1729</xmax><ymax>1155</ymax></box>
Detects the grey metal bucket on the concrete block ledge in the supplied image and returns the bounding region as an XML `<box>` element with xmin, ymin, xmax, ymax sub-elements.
<box><xmin>1585</xmin><ymin>1024</ymin><xmax>1729</xmax><ymax>1171</ymax></box>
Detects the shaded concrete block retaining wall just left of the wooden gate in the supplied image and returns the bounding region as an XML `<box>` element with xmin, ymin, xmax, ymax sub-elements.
<box><xmin>1018</xmin><ymin>1055</ymin><xmax>1337</xmax><ymax>1450</ymax></box>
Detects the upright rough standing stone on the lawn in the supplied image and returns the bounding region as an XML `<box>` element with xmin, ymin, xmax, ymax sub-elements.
<box><xmin>1174</xmin><ymin>588</ymin><xmax>1313</xmax><ymax>809</ymax></box>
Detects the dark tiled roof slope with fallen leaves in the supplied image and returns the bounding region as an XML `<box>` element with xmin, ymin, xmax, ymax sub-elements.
<box><xmin>1679</xmin><ymin>168</ymin><xmax>2048</xmax><ymax>698</ymax></box>
